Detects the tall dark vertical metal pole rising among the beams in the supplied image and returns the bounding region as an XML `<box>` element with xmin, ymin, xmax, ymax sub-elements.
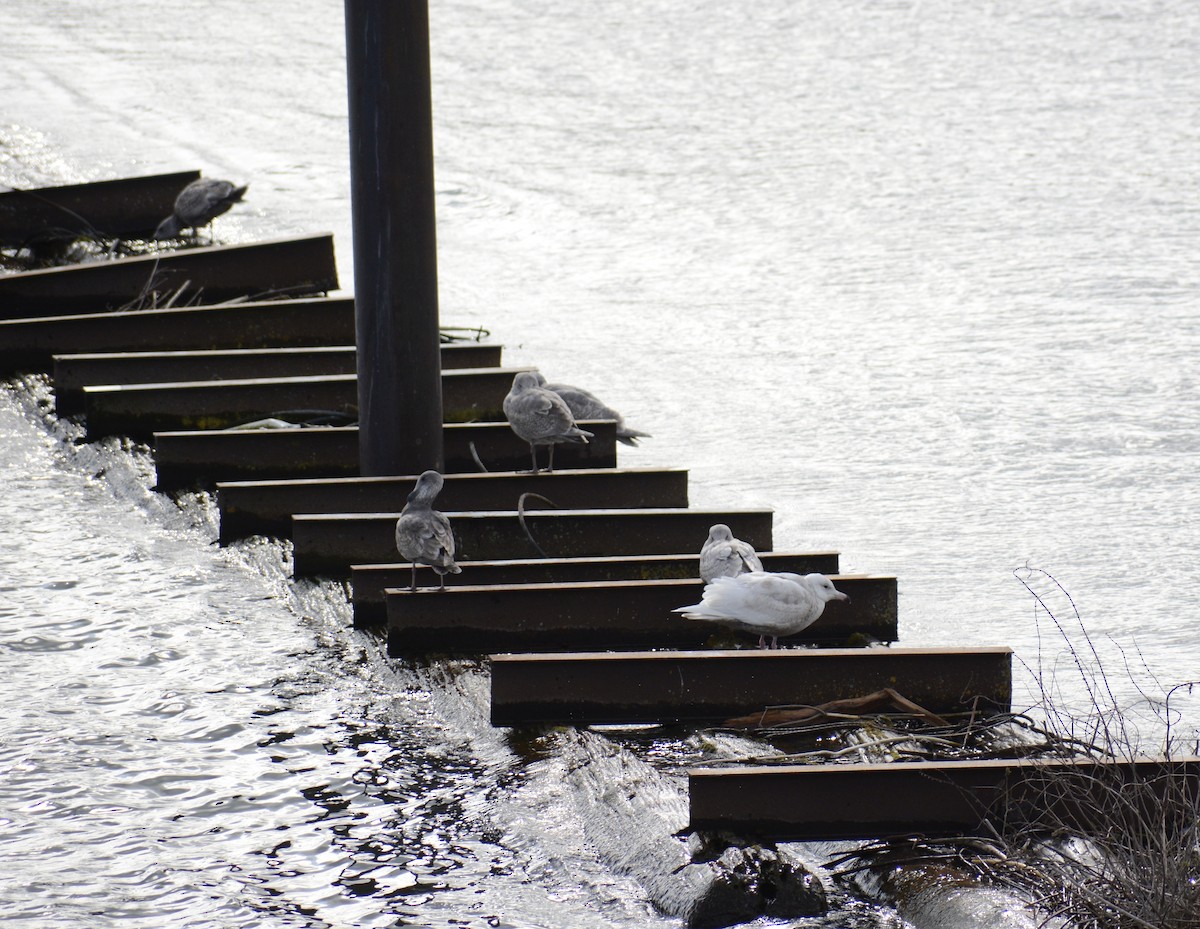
<box><xmin>346</xmin><ymin>0</ymin><xmax>443</xmax><ymax>475</ymax></box>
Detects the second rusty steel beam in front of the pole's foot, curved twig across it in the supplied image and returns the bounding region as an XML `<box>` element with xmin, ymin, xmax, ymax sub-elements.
<box><xmin>292</xmin><ymin>508</ymin><xmax>772</xmax><ymax>577</ymax></box>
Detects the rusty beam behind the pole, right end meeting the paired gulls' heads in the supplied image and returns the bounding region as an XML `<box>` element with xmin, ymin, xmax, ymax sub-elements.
<box><xmin>76</xmin><ymin>367</ymin><xmax>522</xmax><ymax>440</ymax></box>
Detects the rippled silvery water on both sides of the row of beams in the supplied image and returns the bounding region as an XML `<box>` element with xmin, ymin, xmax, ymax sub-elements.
<box><xmin>0</xmin><ymin>0</ymin><xmax>1200</xmax><ymax>927</ymax></box>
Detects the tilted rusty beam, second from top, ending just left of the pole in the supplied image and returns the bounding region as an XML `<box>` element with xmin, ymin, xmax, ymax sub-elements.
<box><xmin>0</xmin><ymin>234</ymin><xmax>337</xmax><ymax>319</ymax></box>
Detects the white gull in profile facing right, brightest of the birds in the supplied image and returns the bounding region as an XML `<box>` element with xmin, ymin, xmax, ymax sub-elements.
<box><xmin>672</xmin><ymin>571</ymin><xmax>850</xmax><ymax>648</ymax></box>
